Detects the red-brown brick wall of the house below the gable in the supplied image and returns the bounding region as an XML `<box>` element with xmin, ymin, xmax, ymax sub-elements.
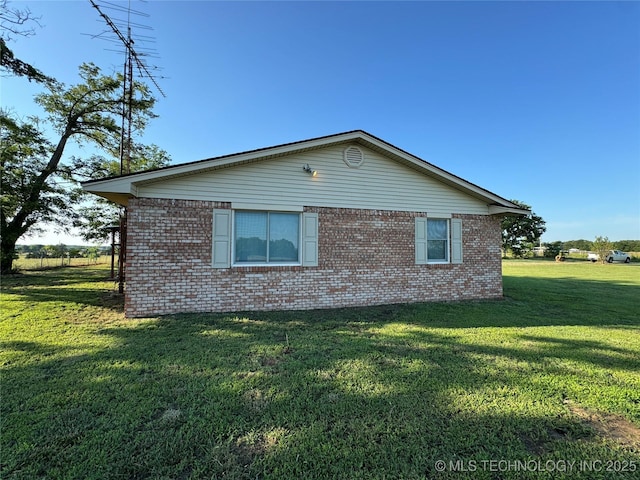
<box><xmin>125</xmin><ymin>199</ymin><xmax>502</xmax><ymax>317</ymax></box>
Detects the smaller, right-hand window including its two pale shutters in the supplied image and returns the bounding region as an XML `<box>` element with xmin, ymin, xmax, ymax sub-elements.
<box><xmin>415</xmin><ymin>217</ymin><xmax>462</xmax><ymax>264</ymax></box>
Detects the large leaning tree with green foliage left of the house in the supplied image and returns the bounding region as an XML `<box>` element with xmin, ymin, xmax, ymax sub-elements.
<box><xmin>0</xmin><ymin>64</ymin><xmax>155</xmax><ymax>273</ymax></box>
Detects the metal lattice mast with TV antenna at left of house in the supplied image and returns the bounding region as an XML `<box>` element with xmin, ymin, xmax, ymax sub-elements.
<box><xmin>89</xmin><ymin>0</ymin><xmax>166</xmax><ymax>293</ymax></box>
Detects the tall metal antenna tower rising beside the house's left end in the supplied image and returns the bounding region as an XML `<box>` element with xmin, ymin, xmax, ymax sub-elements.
<box><xmin>89</xmin><ymin>0</ymin><xmax>166</xmax><ymax>293</ymax></box>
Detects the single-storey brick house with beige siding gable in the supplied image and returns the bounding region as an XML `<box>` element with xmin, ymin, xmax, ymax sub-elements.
<box><xmin>83</xmin><ymin>130</ymin><xmax>529</xmax><ymax>317</ymax></box>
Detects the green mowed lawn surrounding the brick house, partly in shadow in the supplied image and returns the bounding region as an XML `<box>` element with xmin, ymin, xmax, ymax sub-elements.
<box><xmin>0</xmin><ymin>261</ymin><xmax>640</xmax><ymax>479</ymax></box>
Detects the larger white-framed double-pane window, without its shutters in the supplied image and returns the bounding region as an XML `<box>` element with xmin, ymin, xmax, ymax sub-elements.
<box><xmin>234</xmin><ymin>211</ymin><xmax>300</xmax><ymax>263</ymax></box>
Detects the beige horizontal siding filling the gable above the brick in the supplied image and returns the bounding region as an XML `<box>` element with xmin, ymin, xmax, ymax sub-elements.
<box><xmin>137</xmin><ymin>145</ymin><xmax>488</xmax><ymax>215</ymax></box>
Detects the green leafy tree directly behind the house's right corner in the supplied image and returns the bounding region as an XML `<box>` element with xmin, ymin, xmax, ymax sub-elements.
<box><xmin>502</xmin><ymin>200</ymin><xmax>547</xmax><ymax>257</ymax></box>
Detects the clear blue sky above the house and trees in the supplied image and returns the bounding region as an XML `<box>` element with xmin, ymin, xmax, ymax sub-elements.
<box><xmin>5</xmin><ymin>0</ymin><xmax>640</xmax><ymax>244</ymax></box>
